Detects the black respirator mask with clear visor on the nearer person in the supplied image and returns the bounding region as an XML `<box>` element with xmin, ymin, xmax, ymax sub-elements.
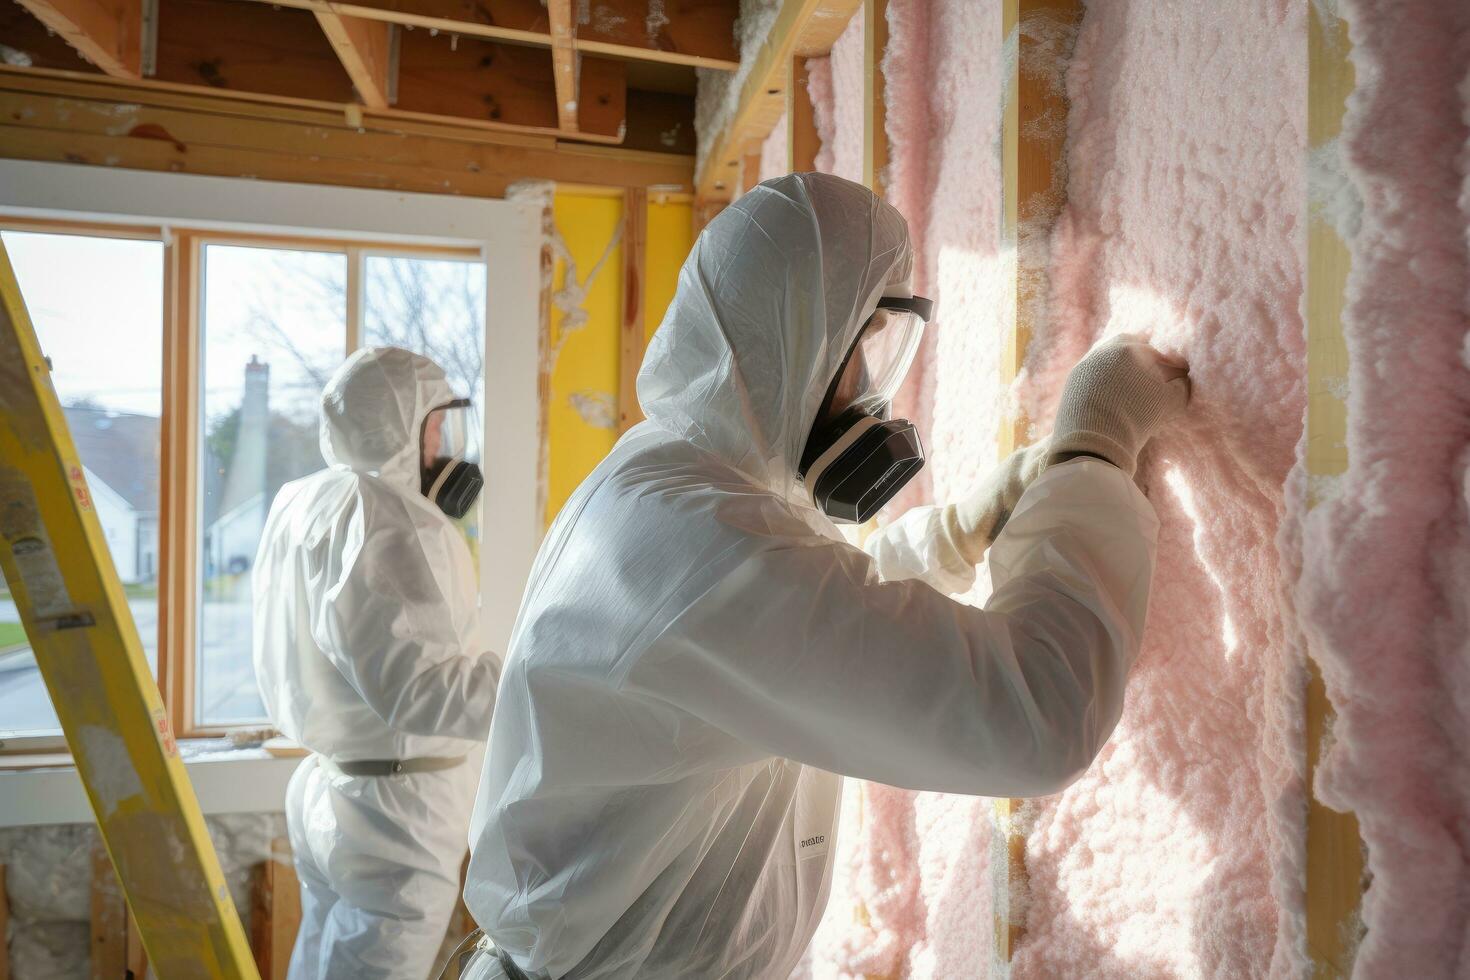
<box><xmin>800</xmin><ymin>297</ymin><xmax>933</xmax><ymax>525</ymax></box>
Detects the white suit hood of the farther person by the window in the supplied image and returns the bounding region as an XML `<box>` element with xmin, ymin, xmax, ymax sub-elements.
<box><xmin>320</xmin><ymin>347</ymin><xmax>456</xmax><ymax>494</ymax></box>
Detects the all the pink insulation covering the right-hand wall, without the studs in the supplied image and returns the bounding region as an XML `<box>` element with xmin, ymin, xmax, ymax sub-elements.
<box><xmin>696</xmin><ymin>0</ymin><xmax>1470</xmax><ymax>979</ymax></box>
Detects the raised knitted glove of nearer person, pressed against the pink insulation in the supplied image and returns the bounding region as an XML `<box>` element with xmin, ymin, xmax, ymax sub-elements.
<box><xmin>1050</xmin><ymin>334</ymin><xmax>1189</xmax><ymax>476</ymax></box>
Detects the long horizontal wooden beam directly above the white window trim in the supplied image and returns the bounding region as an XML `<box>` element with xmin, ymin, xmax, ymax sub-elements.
<box><xmin>0</xmin><ymin>68</ymin><xmax>692</xmax><ymax>197</ymax></box>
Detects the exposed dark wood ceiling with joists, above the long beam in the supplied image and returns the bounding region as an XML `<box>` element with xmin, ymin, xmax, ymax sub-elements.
<box><xmin>0</xmin><ymin>0</ymin><xmax>705</xmax><ymax>143</ymax></box>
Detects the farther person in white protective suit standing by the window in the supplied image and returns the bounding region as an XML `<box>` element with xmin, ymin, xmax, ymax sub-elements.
<box><xmin>254</xmin><ymin>347</ymin><xmax>500</xmax><ymax>980</ymax></box>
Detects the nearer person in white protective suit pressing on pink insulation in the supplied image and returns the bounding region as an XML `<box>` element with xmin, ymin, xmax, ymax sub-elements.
<box><xmin>465</xmin><ymin>173</ymin><xmax>1188</xmax><ymax>980</ymax></box>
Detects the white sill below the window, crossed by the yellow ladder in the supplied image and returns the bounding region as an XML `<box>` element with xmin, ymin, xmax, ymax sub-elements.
<box><xmin>0</xmin><ymin>739</ymin><xmax>301</xmax><ymax>827</ymax></box>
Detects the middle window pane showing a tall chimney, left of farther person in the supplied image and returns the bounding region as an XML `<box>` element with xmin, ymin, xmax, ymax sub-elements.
<box><xmin>196</xmin><ymin>245</ymin><xmax>347</xmax><ymax>724</ymax></box>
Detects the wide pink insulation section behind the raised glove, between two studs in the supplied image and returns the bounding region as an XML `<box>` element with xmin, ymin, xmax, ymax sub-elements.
<box><xmin>1011</xmin><ymin>0</ymin><xmax>1307</xmax><ymax>979</ymax></box>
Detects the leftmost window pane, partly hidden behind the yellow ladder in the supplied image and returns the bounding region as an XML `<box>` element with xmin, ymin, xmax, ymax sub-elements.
<box><xmin>0</xmin><ymin>232</ymin><xmax>163</xmax><ymax>738</ymax></box>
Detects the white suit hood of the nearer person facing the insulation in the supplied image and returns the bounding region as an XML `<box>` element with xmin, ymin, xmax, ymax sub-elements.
<box><xmin>638</xmin><ymin>173</ymin><xmax>913</xmax><ymax>502</ymax></box>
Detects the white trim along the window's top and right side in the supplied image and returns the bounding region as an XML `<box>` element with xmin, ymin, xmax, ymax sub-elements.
<box><xmin>0</xmin><ymin>160</ymin><xmax>541</xmax><ymax>743</ymax></box>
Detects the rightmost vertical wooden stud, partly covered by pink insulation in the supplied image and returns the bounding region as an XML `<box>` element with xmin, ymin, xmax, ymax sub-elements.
<box><xmin>1304</xmin><ymin>3</ymin><xmax>1364</xmax><ymax>980</ymax></box>
